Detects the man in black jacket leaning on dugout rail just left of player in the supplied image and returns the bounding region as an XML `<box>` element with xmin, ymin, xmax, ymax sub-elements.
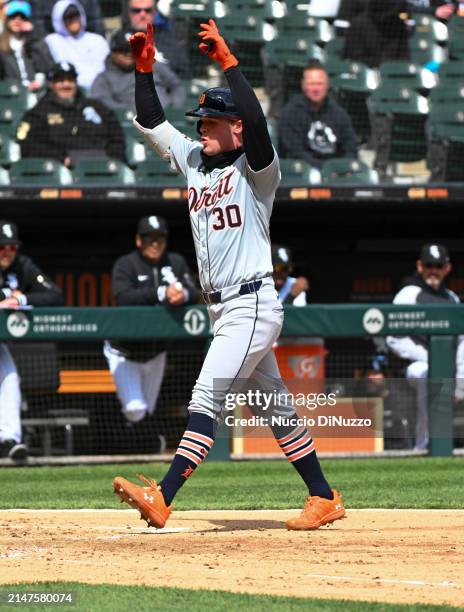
<box><xmin>104</xmin><ymin>215</ymin><xmax>198</xmax><ymax>423</ymax></box>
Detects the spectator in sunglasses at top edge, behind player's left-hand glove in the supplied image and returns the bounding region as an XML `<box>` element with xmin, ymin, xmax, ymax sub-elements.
<box><xmin>115</xmin><ymin>0</ymin><xmax>192</xmax><ymax>79</ymax></box>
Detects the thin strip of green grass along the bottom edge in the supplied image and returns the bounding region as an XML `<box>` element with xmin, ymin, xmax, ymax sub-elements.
<box><xmin>0</xmin><ymin>582</ymin><xmax>462</xmax><ymax>612</ymax></box>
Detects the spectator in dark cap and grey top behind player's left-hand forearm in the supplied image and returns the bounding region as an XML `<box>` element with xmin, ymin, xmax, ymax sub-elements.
<box><xmin>90</xmin><ymin>30</ymin><xmax>185</xmax><ymax>108</ymax></box>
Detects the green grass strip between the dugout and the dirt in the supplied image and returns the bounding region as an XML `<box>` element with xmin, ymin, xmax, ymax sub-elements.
<box><xmin>0</xmin><ymin>457</ymin><xmax>464</xmax><ymax>510</ymax></box>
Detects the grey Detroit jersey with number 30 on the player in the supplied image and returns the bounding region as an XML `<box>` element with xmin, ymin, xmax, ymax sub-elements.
<box><xmin>134</xmin><ymin>121</ymin><xmax>280</xmax><ymax>291</ymax></box>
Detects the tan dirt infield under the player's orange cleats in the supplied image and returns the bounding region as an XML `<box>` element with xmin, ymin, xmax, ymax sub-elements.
<box><xmin>0</xmin><ymin>510</ymin><xmax>464</xmax><ymax>606</ymax></box>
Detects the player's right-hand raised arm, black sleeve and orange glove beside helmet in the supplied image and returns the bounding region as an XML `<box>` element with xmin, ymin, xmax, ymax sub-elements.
<box><xmin>198</xmin><ymin>19</ymin><xmax>274</xmax><ymax>171</ymax></box>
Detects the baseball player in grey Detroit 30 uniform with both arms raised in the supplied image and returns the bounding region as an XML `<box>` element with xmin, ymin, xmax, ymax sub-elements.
<box><xmin>113</xmin><ymin>19</ymin><xmax>345</xmax><ymax>530</ymax></box>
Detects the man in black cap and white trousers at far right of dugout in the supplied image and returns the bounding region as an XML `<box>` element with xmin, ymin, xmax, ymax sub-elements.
<box><xmin>387</xmin><ymin>244</ymin><xmax>464</xmax><ymax>451</ymax></box>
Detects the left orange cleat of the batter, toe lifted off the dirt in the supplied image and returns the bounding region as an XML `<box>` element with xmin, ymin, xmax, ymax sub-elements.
<box><xmin>113</xmin><ymin>474</ymin><xmax>172</xmax><ymax>529</ymax></box>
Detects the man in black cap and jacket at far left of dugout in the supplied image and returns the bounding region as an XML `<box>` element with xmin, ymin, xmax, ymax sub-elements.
<box><xmin>0</xmin><ymin>221</ymin><xmax>63</xmax><ymax>460</ymax></box>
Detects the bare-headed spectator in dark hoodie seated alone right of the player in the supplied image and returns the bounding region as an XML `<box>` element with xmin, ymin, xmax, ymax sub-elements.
<box><xmin>279</xmin><ymin>60</ymin><xmax>357</xmax><ymax>167</ymax></box>
